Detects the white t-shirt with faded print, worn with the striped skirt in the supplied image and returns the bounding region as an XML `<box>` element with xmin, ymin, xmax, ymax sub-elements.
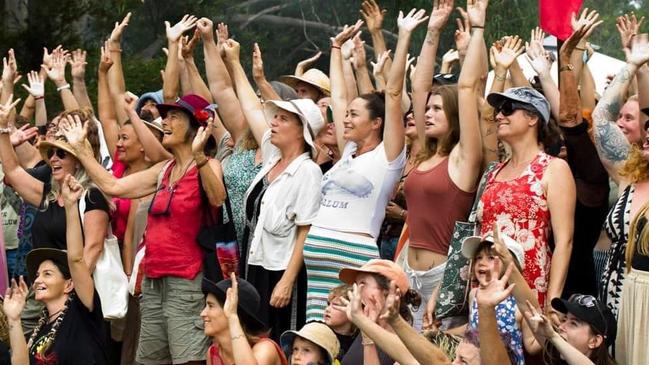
<box><xmin>313</xmin><ymin>142</ymin><xmax>406</xmax><ymax>239</ymax></box>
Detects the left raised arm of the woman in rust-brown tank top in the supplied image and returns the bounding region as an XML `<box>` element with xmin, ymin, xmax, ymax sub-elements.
<box><xmin>412</xmin><ymin>0</ymin><xmax>453</xmax><ymax>146</ymax></box>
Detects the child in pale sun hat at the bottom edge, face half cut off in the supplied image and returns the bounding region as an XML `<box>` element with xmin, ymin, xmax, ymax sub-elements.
<box><xmin>280</xmin><ymin>322</ymin><xmax>340</xmax><ymax>365</ymax></box>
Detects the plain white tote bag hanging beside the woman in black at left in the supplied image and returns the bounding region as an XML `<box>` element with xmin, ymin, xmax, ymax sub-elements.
<box><xmin>79</xmin><ymin>195</ymin><xmax>128</xmax><ymax>319</ymax></box>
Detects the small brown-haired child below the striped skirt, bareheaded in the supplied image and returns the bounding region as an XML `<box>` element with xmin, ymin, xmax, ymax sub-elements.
<box><xmin>324</xmin><ymin>284</ymin><xmax>357</xmax><ymax>360</ymax></box>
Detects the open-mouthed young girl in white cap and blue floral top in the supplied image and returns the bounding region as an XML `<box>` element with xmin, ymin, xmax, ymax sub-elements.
<box><xmin>462</xmin><ymin>235</ymin><xmax>541</xmax><ymax>365</ymax></box>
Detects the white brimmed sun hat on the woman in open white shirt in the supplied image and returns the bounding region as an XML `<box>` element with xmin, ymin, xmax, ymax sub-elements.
<box><xmin>264</xmin><ymin>99</ymin><xmax>325</xmax><ymax>156</ymax></box>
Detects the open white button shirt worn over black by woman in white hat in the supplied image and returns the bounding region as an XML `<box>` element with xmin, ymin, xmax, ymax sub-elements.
<box><xmin>244</xmin><ymin>130</ymin><xmax>322</xmax><ymax>270</ymax></box>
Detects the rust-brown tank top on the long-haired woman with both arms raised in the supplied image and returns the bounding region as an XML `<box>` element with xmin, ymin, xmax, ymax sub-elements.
<box><xmin>403</xmin><ymin>157</ymin><xmax>475</xmax><ymax>255</ymax></box>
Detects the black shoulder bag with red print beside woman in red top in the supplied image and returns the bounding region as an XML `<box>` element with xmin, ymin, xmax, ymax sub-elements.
<box><xmin>196</xmin><ymin>174</ymin><xmax>239</xmax><ymax>282</ymax></box>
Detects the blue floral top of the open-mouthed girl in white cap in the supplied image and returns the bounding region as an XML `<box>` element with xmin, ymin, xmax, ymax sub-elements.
<box><xmin>469</xmin><ymin>289</ymin><xmax>525</xmax><ymax>365</ymax></box>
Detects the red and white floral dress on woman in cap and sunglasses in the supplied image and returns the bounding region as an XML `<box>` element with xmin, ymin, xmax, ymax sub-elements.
<box><xmin>478</xmin><ymin>152</ymin><xmax>553</xmax><ymax>308</ymax></box>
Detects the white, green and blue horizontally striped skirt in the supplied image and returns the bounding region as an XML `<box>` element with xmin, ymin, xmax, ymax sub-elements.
<box><xmin>304</xmin><ymin>226</ymin><xmax>379</xmax><ymax>322</ymax></box>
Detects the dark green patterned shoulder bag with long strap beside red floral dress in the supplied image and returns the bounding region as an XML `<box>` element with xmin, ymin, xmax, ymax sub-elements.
<box><xmin>435</xmin><ymin>161</ymin><xmax>497</xmax><ymax>319</ymax></box>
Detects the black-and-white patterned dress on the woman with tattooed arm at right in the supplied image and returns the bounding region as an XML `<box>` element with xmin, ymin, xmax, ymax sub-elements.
<box><xmin>599</xmin><ymin>185</ymin><xmax>635</xmax><ymax>318</ymax></box>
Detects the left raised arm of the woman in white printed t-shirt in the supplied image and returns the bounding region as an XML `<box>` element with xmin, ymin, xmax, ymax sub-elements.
<box><xmin>329</xmin><ymin>20</ymin><xmax>363</xmax><ymax>153</ymax></box>
